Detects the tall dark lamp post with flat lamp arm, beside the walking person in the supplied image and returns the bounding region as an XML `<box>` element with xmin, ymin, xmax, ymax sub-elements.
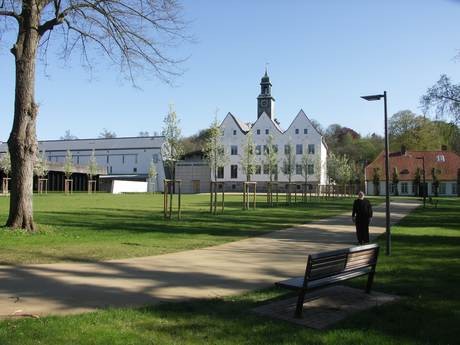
<box><xmin>361</xmin><ymin>91</ymin><xmax>391</xmax><ymax>255</ymax></box>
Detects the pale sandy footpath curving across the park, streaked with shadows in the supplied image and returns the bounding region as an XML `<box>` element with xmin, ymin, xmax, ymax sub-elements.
<box><xmin>0</xmin><ymin>201</ymin><xmax>419</xmax><ymax>317</ymax></box>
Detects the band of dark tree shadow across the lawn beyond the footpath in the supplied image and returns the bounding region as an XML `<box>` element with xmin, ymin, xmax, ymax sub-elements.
<box><xmin>37</xmin><ymin>203</ymin><xmax>352</xmax><ymax>237</ymax></box>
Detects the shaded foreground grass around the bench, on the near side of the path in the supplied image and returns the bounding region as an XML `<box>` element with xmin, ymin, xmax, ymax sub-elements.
<box><xmin>0</xmin><ymin>199</ymin><xmax>460</xmax><ymax>345</ymax></box>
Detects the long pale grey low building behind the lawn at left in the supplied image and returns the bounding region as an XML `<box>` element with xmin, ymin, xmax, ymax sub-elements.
<box><xmin>0</xmin><ymin>136</ymin><xmax>165</xmax><ymax>191</ymax></box>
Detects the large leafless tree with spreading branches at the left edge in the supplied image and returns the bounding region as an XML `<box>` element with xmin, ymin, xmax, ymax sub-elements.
<box><xmin>0</xmin><ymin>0</ymin><xmax>184</xmax><ymax>230</ymax></box>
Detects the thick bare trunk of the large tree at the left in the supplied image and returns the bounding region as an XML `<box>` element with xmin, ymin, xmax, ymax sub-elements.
<box><xmin>6</xmin><ymin>0</ymin><xmax>40</xmax><ymax>231</ymax></box>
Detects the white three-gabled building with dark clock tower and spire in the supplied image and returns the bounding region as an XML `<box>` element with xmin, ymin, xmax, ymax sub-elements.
<box><xmin>218</xmin><ymin>71</ymin><xmax>327</xmax><ymax>190</ymax></box>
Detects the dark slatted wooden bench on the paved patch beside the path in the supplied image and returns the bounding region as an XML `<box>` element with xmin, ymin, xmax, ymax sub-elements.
<box><xmin>275</xmin><ymin>244</ymin><xmax>379</xmax><ymax>318</ymax></box>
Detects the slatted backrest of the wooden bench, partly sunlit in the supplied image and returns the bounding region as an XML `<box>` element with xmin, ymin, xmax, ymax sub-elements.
<box><xmin>304</xmin><ymin>244</ymin><xmax>379</xmax><ymax>284</ymax></box>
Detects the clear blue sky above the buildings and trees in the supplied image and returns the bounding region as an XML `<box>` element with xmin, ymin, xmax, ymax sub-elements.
<box><xmin>0</xmin><ymin>0</ymin><xmax>460</xmax><ymax>141</ymax></box>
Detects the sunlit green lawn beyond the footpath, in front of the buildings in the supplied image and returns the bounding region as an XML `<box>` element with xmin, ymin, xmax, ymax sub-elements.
<box><xmin>0</xmin><ymin>193</ymin><xmax>352</xmax><ymax>264</ymax></box>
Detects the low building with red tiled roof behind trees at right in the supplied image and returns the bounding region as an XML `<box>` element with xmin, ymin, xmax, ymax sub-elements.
<box><xmin>365</xmin><ymin>148</ymin><xmax>460</xmax><ymax>196</ymax></box>
